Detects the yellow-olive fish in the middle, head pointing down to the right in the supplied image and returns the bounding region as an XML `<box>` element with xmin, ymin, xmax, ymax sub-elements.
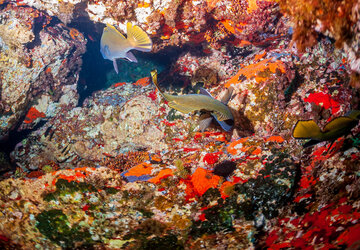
<box><xmin>151</xmin><ymin>70</ymin><xmax>234</xmax><ymax>131</ymax></box>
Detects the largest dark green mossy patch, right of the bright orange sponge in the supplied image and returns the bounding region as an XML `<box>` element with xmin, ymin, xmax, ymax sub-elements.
<box><xmin>190</xmin><ymin>150</ymin><xmax>298</xmax><ymax>237</ymax></box>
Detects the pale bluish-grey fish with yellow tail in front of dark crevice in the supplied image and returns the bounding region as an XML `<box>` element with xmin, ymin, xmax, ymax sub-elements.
<box><xmin>100</xmin><ymin>23</ymin><xmax>152</xmax><ymax>73</ymax></box>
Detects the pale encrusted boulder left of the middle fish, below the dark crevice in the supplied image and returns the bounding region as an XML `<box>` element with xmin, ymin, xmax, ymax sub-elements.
<box><xmin>12</xmin><ymin>84</ymin><xmax>167</xmax><ymax>170</ymax></box>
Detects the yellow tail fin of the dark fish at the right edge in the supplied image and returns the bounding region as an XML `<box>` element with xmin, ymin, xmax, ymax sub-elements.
<box><xmin>292</xmin><ymin>120</ymin><xmax>322</xmax><ymax>139</ymax></box>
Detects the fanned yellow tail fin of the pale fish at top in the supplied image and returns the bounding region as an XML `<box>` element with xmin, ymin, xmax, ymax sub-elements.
<box><xmin>126</xmin><ymin>22</ymin><xmax>152</xmax><ymax>52</ymax></box>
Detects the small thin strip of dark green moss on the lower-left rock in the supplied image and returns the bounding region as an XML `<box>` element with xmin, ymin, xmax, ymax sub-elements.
<box><xmin>44</xmin><ymin>179</ymin><xmax>97</xmax><ymax>201</ymax></box>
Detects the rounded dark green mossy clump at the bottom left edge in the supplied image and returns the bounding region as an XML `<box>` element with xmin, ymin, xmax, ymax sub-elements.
<box><xmin>36</xmin><ymin>209</ymin><xmax>94</xmax><ymax>248</ymax></box>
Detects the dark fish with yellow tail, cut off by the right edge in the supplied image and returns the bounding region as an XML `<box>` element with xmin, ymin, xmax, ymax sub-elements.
<box><xmin>292</xmin><ymin>110</ymin><xmax>360</xmax><ymax>148</ymax></box>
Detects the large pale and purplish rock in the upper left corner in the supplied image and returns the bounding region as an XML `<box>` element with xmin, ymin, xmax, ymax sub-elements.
<box><xmin>0</xmin><ymin>4</ymin><xmax>86</xmax><ymax>135</ymax></box>
